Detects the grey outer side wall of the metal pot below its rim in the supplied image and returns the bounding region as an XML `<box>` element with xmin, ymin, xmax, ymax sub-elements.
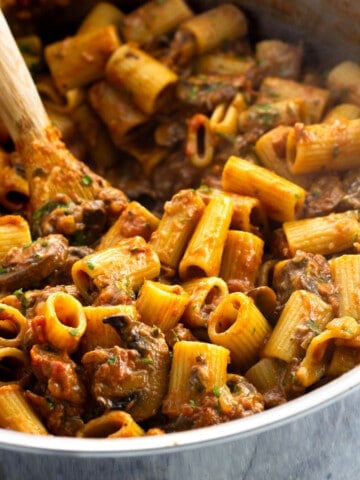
<box><xmin>0</xmin><ymin>389</ymin><xmax>360</xmax><ymax>480</ymax></box>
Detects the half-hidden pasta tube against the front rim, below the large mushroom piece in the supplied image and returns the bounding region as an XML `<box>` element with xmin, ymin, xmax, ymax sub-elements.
<box><xmin>76</xmin><ymin>410</ymin><xmax>145</xmax><ymax>438</ymax></box>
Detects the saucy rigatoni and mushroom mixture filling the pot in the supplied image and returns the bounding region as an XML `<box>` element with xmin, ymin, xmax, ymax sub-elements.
<box><xmin>0</xmin><ymin>0</ymin><xmax>360</xmax><ymax>438</ymax></box>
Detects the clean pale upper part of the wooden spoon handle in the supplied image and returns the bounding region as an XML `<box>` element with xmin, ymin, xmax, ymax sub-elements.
<box><xmin>0</xmin><ymin>9</ymin><xmax>50</xmax><ymax>143</ymax></box>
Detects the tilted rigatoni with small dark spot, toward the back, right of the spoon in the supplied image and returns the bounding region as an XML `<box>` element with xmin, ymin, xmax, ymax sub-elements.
<box><xmin>105</xmin><ymin>43</ymin><xmax>178</xmax><ymax>115</ymax></box>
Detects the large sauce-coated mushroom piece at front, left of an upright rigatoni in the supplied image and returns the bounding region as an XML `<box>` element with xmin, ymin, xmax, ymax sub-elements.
<box><xmin>81</xmin><ymin>316</ymin><xmax>170</xmax><ymax>422</ymax></box>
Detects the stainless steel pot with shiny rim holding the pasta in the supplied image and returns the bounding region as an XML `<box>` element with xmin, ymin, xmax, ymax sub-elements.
<box><xmin>0</xmin><ymin>0</ymin><xmax>360</xmax><ymax>480</ymax></box>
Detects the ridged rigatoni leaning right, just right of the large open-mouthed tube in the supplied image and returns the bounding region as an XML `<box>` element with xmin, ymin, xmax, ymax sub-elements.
<box><xmin>261</xmin><ymin>290</ymin><xmax>332</xmax><ymax>363</ymax></box>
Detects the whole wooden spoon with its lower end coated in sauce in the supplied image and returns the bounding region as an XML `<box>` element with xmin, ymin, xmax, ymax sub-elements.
<box><xmin>0</xmin><ymin>9</ymin><xmax>127</xmax><ymax>218</ymax></box>
